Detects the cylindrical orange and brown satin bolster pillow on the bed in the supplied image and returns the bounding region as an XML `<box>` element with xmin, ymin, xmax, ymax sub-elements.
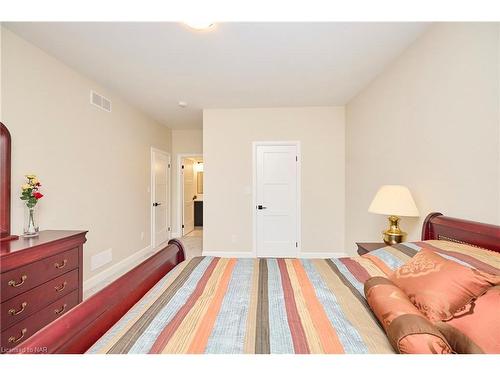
<box><xmin>365</xmin><ymin>276</ymin><xmax>452</xmax><ymax>354</ymax></box>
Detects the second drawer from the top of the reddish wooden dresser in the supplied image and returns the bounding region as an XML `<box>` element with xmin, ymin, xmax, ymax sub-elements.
<box><xmin>1</xmin><ymin>269</ymin><xmax>78</xmax><ymax>331</ymax></box>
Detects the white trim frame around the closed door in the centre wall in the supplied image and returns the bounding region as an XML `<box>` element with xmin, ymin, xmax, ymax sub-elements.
<box><xmin>252</xmin><ymin>141</ymin><xmax>302</xmax><ymax>258</ymax></box>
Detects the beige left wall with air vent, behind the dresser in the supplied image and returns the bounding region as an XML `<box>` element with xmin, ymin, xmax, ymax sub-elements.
<box><xmin>2</xmin><ymin>29</ymin><xmax>171</xmax><ymax>279</ymax></box>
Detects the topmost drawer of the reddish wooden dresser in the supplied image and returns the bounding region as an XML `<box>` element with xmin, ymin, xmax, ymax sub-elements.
<box><xmin>1</xmin><ymin>248</ymin><xmax>78</xmax><ymax>302</ymax></box>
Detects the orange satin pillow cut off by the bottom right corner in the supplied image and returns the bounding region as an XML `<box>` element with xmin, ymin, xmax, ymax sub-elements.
<box><xmin>436</xmin><ymin>286</ymin><xmax>500</xmax><ymax>354</ymax></box>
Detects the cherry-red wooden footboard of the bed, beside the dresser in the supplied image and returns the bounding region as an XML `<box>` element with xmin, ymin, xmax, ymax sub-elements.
<box><xmin>9</xmin><ymin>240</ymin><xmax>185</xmax><ymax>354</ymax></box>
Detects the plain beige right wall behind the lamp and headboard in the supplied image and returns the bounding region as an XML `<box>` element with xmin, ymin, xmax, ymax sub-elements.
<box><xmin>346</xmin><ymin>23</ymin><xmax>500</xmax><ymax>254</ymax></box>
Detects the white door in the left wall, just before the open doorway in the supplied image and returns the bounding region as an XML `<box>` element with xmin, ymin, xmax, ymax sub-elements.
<box><xmin>151</xmin><ymin>149</ymin><xmax>170</xmax><ymax>247</ymax></box>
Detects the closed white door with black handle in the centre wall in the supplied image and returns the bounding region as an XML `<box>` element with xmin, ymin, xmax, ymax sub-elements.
<box><xmin>254</xmin><ymin>143</ymin><xmax>300</xmax><ymax>257</ymax></box>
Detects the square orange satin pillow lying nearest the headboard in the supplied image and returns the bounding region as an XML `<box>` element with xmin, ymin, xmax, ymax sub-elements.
<box><xmin>389</xmin><ymin>249</ymin><xmax>500</xmax><ymax>322</ymax></box>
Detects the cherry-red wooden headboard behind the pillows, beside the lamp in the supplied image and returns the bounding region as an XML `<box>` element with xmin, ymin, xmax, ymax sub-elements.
<box><xmin>422</xmin><ymin>212</ymin><xmax>500</xmax><ymax>252</ymax></box>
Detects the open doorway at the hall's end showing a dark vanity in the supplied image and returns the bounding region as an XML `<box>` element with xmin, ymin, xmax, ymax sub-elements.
<box><xmin>179</xmin><ymin>155</ymin><xmax>204</xmax><ymax>237</ymax></box>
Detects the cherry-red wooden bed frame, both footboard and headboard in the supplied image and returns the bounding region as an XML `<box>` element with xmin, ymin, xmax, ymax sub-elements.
<box><xmin>13</xmin><ymin>213</ymin><xmax>500</xmax><ymax>353</ymax></box>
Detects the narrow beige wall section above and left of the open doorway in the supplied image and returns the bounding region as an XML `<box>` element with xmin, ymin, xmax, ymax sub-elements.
<box><xmin>172</xmin><ymin>129</ymin><xmax>203</xmax><ymax>236</ymax></box>
